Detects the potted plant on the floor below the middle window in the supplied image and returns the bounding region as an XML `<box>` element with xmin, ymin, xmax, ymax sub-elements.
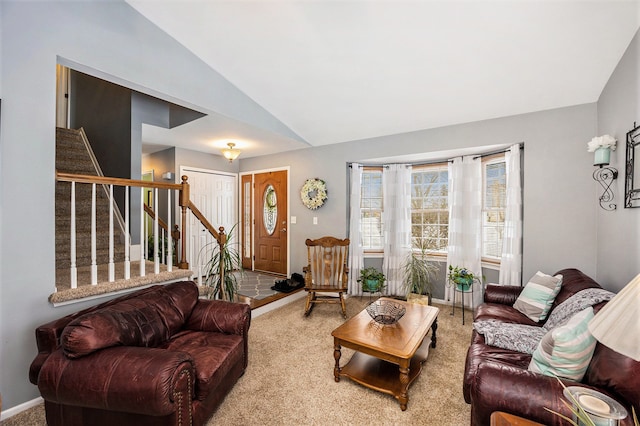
<box><xmin>402</xmin><ymin>244</ymin><xmax>439</xmax><ymax>305</ymax></box>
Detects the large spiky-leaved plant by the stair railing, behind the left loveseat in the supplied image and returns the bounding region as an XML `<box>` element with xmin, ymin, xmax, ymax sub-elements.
<box><xmin>204</xmin><ymin>225</ymin><xmax>242</xmax><ymax>302</ymax></box>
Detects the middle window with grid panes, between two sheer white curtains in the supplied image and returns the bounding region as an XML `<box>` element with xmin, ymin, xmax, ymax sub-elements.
<box><xmin>411</xmin><ymin>163</ymin><xmax>449</xmax><ymax>253</ymax></box>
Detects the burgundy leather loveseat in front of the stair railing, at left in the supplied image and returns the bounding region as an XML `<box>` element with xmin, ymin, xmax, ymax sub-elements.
<box><xmin>29</xmin><ymin>281</ymin><xmax>251</xmax><ymax>426</ymax></box>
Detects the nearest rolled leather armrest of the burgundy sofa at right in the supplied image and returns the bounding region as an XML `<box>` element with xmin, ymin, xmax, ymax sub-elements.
<box><xmin>471</xmin><ymin>361</ymin><xmax>608</xmax><ymax>426</ymax></box>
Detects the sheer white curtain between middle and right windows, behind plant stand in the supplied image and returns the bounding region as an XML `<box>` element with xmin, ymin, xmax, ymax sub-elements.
<box><xmin>445</xmin><ymin>156</ymin><xmax>482</xmax><ymax>306</ymax></box>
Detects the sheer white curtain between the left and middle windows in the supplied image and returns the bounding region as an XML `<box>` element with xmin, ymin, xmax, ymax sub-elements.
<box><xmin>382</xmin><ymin>164</ymin><xmax>411</xmax><ymax>296</ymax></box>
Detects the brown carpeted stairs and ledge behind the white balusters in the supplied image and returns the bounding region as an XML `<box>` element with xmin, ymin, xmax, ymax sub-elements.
<box><xmin>49</xmin><ymin>128</ymin><xmax>193</xmax><ymax>305</ymax></box>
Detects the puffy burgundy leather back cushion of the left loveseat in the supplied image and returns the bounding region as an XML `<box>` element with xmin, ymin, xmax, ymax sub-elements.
<box><xmin>60</xmin><ymin>281</ymin><xmax>198</xmax><ymax>358</ymax></box>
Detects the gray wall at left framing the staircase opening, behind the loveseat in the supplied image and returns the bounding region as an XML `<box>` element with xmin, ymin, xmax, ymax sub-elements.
<box><xmin>0</xmin><ymin>1</ymin><xmax>298</xmax><ymax>409</ymax></box>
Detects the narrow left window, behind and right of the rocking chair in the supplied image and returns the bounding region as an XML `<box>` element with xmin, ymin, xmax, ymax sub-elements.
<box><xmin>360</xmin><ymin>168</ymin><xmax>383</xmax><ymax>251</ymax></box>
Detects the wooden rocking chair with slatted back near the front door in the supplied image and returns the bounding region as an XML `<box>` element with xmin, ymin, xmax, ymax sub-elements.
<box><xmin>302</xmin><ymin>237</ymin><xmax>349</xmax><ymax>319</ymax></box>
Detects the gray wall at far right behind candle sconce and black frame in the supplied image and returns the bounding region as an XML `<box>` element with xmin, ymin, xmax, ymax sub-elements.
<box><xmin>596</xmin><ymin>28</ymin><xmax>640</xmax><ymax>291</ymax></box>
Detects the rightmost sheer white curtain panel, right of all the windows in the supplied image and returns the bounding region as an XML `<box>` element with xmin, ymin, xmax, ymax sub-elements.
<box><xmin>499</xmin><ymin>144</ymin><xmax>522</xmax><ymax>285</ymax></box>
